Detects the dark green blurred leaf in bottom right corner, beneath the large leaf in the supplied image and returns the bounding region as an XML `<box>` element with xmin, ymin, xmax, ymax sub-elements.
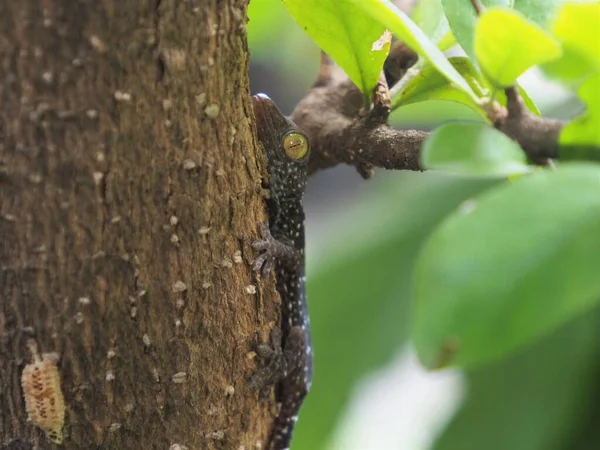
<box><xmin>434</xmin><ymin>310</ymin><xmax>600</xmax><ymax>450</ymax></box>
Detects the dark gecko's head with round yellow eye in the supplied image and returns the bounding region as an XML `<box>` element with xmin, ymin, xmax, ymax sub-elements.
<box><xmin>252</xmin><ymin>94</ymin><xmax>310</xmax><ymax>194</ymax></box>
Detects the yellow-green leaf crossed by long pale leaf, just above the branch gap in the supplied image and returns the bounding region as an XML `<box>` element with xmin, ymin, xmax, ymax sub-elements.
<box><xmin>392</xmin><ymin>56</ymin><xmax>487</xmax><ymax>113</ymax></box>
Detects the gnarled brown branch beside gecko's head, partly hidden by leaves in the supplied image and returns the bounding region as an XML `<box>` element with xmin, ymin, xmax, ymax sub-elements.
<box><xmin>292</xmin><ymin>43</ymin><xmax>565</xmax><ymax>178</ymax></box>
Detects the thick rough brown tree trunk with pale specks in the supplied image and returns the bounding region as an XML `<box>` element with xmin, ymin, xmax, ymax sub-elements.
<box><xmin>0</xmin><ymin>0</ymin><xmax>277</xmax><ymax>450</ymax></box>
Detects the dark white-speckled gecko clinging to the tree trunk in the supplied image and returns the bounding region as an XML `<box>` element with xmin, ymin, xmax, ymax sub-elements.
<box><xmin>250</xmin><ymin>94</ymin><xmax>312</xmax><ymax>450</ymax></box>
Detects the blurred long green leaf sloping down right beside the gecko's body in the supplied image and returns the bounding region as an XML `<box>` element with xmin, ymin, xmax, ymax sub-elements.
<box><xmin>292</xmin><ymin>172</ymin><xmax>493</xmax><ymax>450</ymax></box>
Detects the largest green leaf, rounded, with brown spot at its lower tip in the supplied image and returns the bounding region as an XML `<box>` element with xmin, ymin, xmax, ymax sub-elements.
<box><xmin>412</xmin><ymin>164</ymin><xmax>600</xmax><ymax>368</ymax></box>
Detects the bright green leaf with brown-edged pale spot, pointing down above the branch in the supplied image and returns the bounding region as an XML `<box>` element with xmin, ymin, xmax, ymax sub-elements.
<box><xmin>283</xmin><ymin>0</ymin><xmax>390</xmax><ymax>104</ymax></box>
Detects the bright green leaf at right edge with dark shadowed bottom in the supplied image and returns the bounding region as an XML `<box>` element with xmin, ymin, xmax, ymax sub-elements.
<box><xmin>559</xmin><ymin>73</ymin><xmax>600</xmax><ymax>156</ymax></box>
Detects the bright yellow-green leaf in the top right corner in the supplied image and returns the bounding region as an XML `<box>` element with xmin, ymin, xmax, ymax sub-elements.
<box><xmin>543</xmin><ymin>3</ymin><xmax>600</xmax><ymax>83</ymax></box>
